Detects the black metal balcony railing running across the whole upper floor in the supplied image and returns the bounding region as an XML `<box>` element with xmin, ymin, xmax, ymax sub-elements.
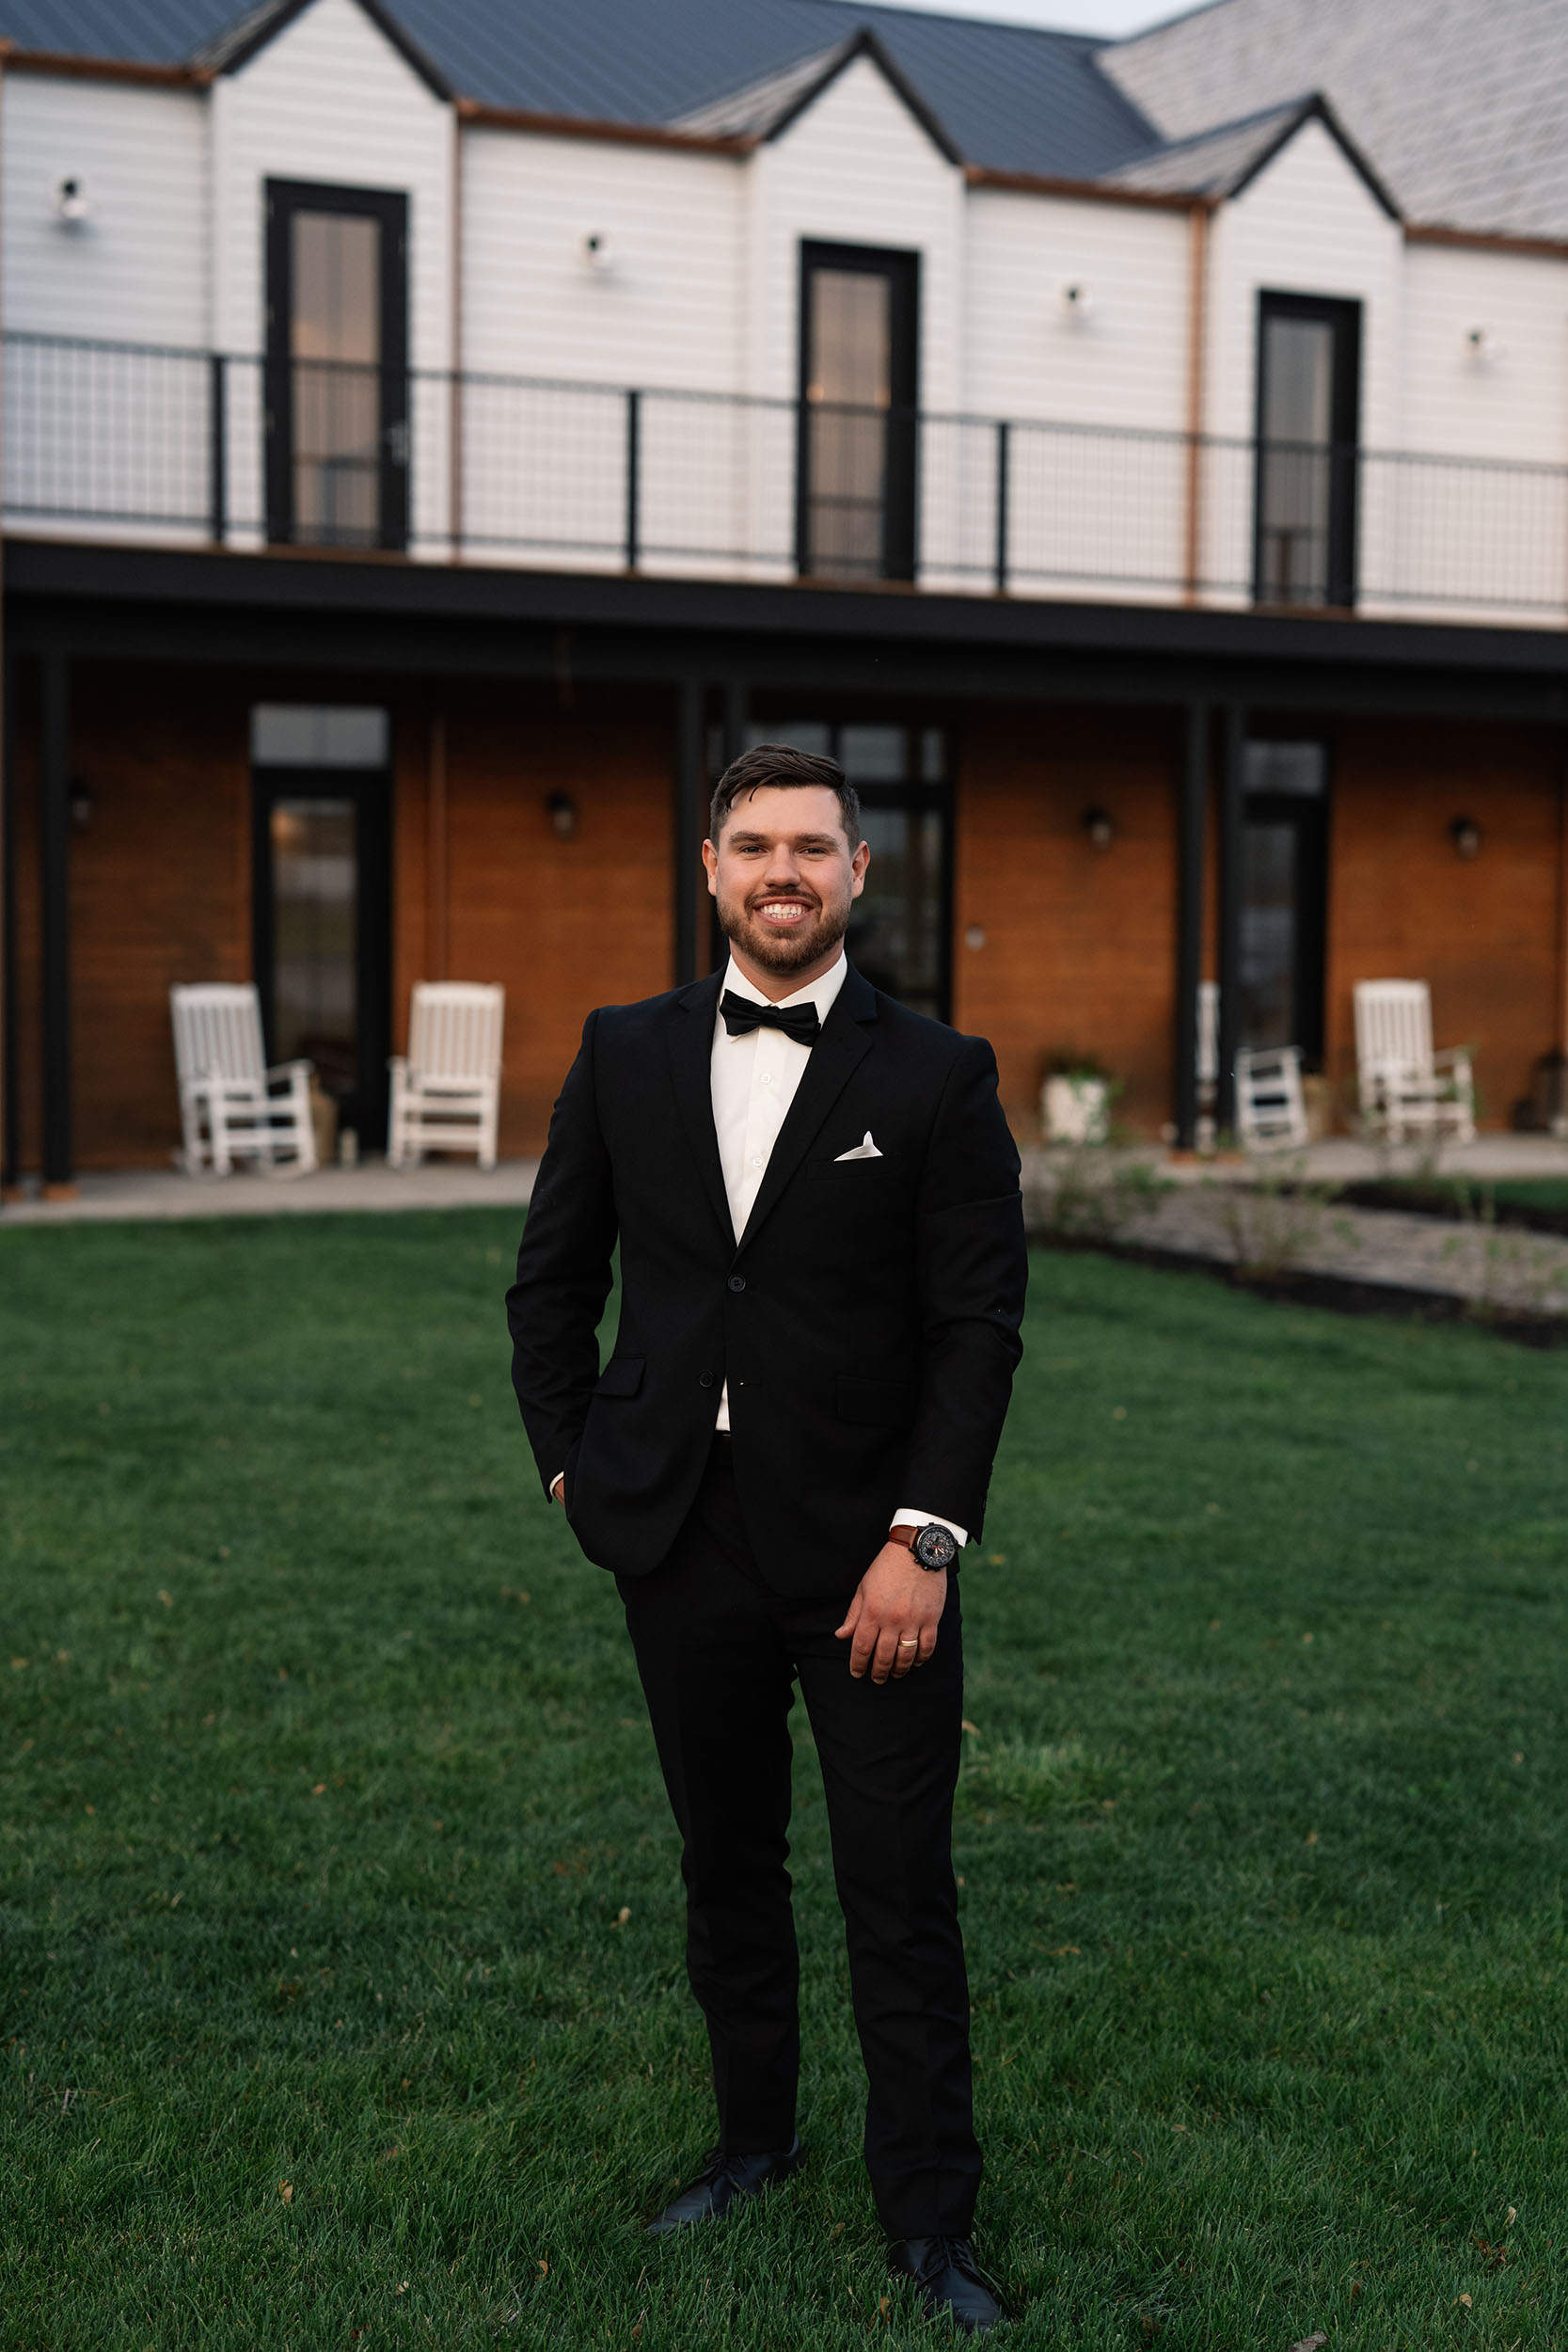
<box><xmin>0</xmin><ymin>332</ymin><xmax>1568</xmax><ymax>628</ymax></box>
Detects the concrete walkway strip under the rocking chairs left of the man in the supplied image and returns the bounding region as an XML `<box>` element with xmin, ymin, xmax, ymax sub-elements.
<box><xmin>0</xmin><ymin>1160</ymin><xmax>538</xmax><ymax>1232</ymax></box>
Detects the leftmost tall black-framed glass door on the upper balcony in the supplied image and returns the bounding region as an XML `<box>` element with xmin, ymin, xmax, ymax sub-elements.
<box><xmin>265</xmin><ymin>179</ymin><xmax>409</xmax><ymax>548</ymax></box>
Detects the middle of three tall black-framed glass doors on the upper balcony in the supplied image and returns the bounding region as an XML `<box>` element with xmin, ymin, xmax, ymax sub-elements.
<box><xmin>795</xmin><ymin>243</ymin><xmax>919</xmax><ymax>581</ymax></box>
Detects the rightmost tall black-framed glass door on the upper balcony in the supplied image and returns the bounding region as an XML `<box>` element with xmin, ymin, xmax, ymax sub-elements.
<box><xmin>1253</xmin><ymin>294</ymin><xmax>1361</xmax><ymax>607</ymax></box>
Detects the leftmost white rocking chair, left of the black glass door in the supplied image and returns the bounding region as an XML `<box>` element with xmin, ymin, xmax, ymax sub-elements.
<box><xmin>169</xmin><ymin>981</ymin><xmax>315</xmax><ymax>1176</ymax></box>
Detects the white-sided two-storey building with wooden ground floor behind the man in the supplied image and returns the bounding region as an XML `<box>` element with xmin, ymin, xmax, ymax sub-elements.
<box><xmin>0</xmin><ymin>0</ymin><xmax>1568</xmax><ymax>1185</ymax></box>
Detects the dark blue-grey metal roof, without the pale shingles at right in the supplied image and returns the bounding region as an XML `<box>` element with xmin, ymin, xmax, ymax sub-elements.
<box><xmin>0</xmin><ymin>0</ymin><xmax>1159</xmax><ymax>179</ymax></box>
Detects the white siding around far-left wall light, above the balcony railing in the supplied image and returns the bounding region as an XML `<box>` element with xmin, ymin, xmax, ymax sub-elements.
<box><xmin>0</xmin><ymin>73</ymin><xmax>209</xmax><ymax>346</ymax></box>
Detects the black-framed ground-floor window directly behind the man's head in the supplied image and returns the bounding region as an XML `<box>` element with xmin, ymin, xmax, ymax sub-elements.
<box><xmin>737</xmin><ymin>713</ymin><xmax>952</xmax><ymax>1021</ymax></box>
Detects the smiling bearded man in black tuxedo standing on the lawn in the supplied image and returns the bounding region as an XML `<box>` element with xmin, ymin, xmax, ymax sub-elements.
<box><xmin>508</xmin><ymin>743</ymin><xmax>1025</xmax><ymax>2333</ymax></box>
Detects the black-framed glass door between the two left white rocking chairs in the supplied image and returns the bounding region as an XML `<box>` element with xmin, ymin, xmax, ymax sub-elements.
<box><xmin>251</xmin><ymin>767</ymin><xmax>390</xmax><ymax>1148</ymax></box>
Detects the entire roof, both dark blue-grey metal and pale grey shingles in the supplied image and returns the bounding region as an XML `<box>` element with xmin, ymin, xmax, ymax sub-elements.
<box><xmin>12</xmin><ymin>0</ymin><xmax>1568</xmax><ymax>243</ymax></box>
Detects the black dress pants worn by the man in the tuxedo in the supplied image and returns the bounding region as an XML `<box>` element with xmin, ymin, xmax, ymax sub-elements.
<box><xmin>618</xmin><ymin>1438</ymin><xmax>980</xmax><ymax>2237</ymax></box>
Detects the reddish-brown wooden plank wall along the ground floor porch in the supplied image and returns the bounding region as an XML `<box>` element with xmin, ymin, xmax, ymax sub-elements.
<box><xmin>6</xmin><ymin>666</ymin><xmax>1563</xmax><ymax>1169</ymax></box>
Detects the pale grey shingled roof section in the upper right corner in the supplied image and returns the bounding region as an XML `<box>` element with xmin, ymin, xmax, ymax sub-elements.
<box><xmin>1101</xmin><ymin>0</ymin><xmax>1568</xmax><ymax>240</ymax></box>
